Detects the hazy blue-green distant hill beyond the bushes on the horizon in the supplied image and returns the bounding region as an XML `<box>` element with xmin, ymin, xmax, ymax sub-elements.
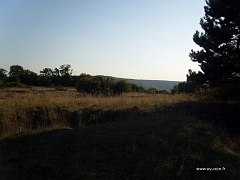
<box><xmin>104</xmin><ymin>76</ymin><xmax>180</xmax><ymax>91</ymax></box>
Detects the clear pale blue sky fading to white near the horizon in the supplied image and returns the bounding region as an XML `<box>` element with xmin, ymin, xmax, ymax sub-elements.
<box><xmin>0</xmin><ymin>0</ymin><xmax>205</xmax><ymax>81</ymax></box>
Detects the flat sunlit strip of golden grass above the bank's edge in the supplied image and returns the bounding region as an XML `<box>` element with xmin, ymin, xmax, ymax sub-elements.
<box><xmin>0</xmin><ymin>87</ymin><xmax>197</xmax><ymax>109</ymax></box>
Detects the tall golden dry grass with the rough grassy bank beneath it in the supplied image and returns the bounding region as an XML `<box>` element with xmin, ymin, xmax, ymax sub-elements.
<box><xmin>0</xmin><ymin>87</ymin><xmax>197</xmax><ymax>139</ymax></box>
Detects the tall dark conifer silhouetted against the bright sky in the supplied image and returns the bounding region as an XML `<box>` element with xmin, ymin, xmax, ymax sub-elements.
<box><xmin>189</xmin><ymin>0</ymin><xmax>240</xmax><ymax>85</ymax></box>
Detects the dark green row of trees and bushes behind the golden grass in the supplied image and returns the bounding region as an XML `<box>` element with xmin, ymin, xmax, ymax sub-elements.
<box><xmin>0</xmin><ymin>64</ymin><xmax>170</xmax><ymax>95</ymax></box>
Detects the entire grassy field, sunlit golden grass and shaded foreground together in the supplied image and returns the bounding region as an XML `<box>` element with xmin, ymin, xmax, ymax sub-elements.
<box><xmin>0</xmin><ymin>87</ymin><xmax>240</xmax><ymax>180</ymax></box>
